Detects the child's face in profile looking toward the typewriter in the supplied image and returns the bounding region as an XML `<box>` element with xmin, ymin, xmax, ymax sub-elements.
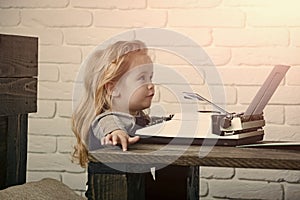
<box><xmin>115</xmin><ymin>55</ymin><xmax>154</xmax><ymax>115</ymax></box>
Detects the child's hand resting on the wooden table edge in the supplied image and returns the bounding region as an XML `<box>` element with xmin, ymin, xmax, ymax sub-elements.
<box><xmin>101</xmin><ymin>130</ymin><xmax>140</xmax><ymax>151</ymax></box>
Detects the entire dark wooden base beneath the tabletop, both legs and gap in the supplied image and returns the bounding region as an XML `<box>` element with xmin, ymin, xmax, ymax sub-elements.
<box><xmin>86</xmin><ymin>162</ymin><xmax>199</xmax><ymax>200</ymax></box>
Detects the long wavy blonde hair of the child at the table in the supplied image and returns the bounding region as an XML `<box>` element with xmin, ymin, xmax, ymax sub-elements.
<box><xmin>72</xmin><ymin>40</ymin><xmax>147</xmax><ymax>167</ymax></box>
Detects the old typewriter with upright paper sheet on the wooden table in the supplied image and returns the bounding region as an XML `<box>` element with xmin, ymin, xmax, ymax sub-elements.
<box><xmin>136</xmin><ymin>65</ymin><xmax>290</xmax><ymax>146</ymax></box>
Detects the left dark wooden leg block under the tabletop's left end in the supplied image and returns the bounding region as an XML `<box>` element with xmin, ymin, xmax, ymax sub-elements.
<box><xmin>86</xmin><ymin>162</ymin><xmax>145</xmax><ymax>200</ymax></box>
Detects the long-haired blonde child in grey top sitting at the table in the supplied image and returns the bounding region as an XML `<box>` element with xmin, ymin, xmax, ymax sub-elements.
<box><xmin>72</xmin><ymin>40</ymin><xmax>154</xmax><ymax>167</ymax></box>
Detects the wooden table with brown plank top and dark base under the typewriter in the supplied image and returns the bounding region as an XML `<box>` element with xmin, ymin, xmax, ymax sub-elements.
<box><xmin>87</xmin><ymin>144</ymin><xmax>300</xmax><ymax>199</ymax></box>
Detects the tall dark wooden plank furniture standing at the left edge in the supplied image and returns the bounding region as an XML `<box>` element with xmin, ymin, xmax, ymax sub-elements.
<box><xmin>0</xmin><ymin>34</ymin><xmax>38</xmax><ymax>189</ymax></box>
